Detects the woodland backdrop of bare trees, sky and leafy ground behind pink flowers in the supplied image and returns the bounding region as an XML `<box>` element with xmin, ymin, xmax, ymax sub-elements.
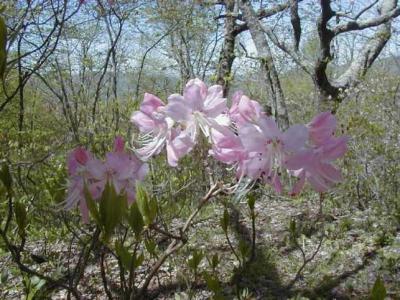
<box><xmin>0</xmin><ymin>0</ymin><xmax>400</xmax><ymax>299</ymax></box>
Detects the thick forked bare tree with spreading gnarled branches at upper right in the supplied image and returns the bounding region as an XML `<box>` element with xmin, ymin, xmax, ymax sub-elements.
<box><xmin>244</xmin><ymin>0</ymin><xmax>400</xmax><ymax>111</ymax></box>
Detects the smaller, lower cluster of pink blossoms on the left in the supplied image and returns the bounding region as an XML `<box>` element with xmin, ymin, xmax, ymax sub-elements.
<box><xmin>66</xmin><ymin>137</ymin><xmax>148</xmax><ymax>223</ymax></box>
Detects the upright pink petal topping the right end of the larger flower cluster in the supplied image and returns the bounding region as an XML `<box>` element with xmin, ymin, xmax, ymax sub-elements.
<box><xmin>309</xmin><ymin>112</ymin><xmax>337</xmax><ymax>145</ymax></box>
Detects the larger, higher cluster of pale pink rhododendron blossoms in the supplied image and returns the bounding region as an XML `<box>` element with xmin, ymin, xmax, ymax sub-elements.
<box><xmin>131</xmin><ymin>79</ymin><xmax>348</xmax><ymax>195</ymax></box>
